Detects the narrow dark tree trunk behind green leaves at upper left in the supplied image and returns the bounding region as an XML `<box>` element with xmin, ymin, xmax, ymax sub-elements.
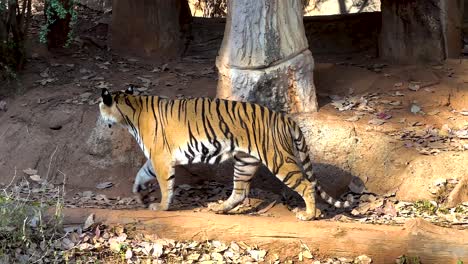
<box><xmin>44</xmin><ymin>0</ymin><xmax>72</xmax><ymax>49</ymax></box>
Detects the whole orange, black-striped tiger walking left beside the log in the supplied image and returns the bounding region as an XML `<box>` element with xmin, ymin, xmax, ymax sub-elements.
<box><xmin>99</xmin><ymin>86</ymin><xmax>352</xmax><ymax>221</ymax></box>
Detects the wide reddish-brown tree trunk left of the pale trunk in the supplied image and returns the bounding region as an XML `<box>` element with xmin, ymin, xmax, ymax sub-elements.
<box><xmin>111</xmin><ymin>0</ymin><xmax>191</xmax><ymax>59</ymax></box>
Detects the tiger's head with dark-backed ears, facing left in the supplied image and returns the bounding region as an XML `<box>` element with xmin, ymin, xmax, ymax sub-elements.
<box><xmin>99</xmin><ymin>86</ymin><xmax>137</xmax><ymax>127</ymax></box>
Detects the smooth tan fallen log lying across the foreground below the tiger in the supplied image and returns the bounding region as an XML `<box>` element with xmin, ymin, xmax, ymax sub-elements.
<box><xmin>59</xmin><ymin>208</ymin><xmax>468</xmax><ymax>263</ymax></box>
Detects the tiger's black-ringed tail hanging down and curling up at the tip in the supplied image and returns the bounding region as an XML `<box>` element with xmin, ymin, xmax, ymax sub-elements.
<box><xmin>291</xmin><ymin>120</ymin><xmax>354</xmax><ymax>208</ymax></box>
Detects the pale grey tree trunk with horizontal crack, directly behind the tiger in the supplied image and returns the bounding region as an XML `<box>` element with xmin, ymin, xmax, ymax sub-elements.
<box><xmin>216</xmin><ymin>0</ymin><xmax>317</xmax><ymax>113</ymax></box>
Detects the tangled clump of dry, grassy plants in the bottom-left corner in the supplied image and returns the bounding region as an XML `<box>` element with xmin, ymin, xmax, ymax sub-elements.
<box><xmin>0</xmin><ymin>170</ymin><xmax>67</xmax><ymax>263</ymax></box>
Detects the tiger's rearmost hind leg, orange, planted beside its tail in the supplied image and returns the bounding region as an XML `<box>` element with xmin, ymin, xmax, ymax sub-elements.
<box><xmin>276</xmin><ymin>162</ymin><xmax>319</xmax><ymax>221</ymax></box>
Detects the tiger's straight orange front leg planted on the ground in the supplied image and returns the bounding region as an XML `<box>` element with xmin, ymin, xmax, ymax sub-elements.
<box><xmin>148</xmin><ymin>158</ymin><xmax>175</xmax><ymax>211</ymax></box>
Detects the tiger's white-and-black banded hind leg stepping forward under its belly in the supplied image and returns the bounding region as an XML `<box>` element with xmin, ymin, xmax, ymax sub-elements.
<box><xmin>208</xmin><ymin>153</ymin><xmax>260</xmax><ymax>213</ymax></box>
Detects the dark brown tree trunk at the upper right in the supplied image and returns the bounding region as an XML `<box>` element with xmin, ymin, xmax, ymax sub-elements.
<box><xmin>380</xmin><ymin>0</ymin><xmax>463</xmax><ymax>63</ymax></box>
